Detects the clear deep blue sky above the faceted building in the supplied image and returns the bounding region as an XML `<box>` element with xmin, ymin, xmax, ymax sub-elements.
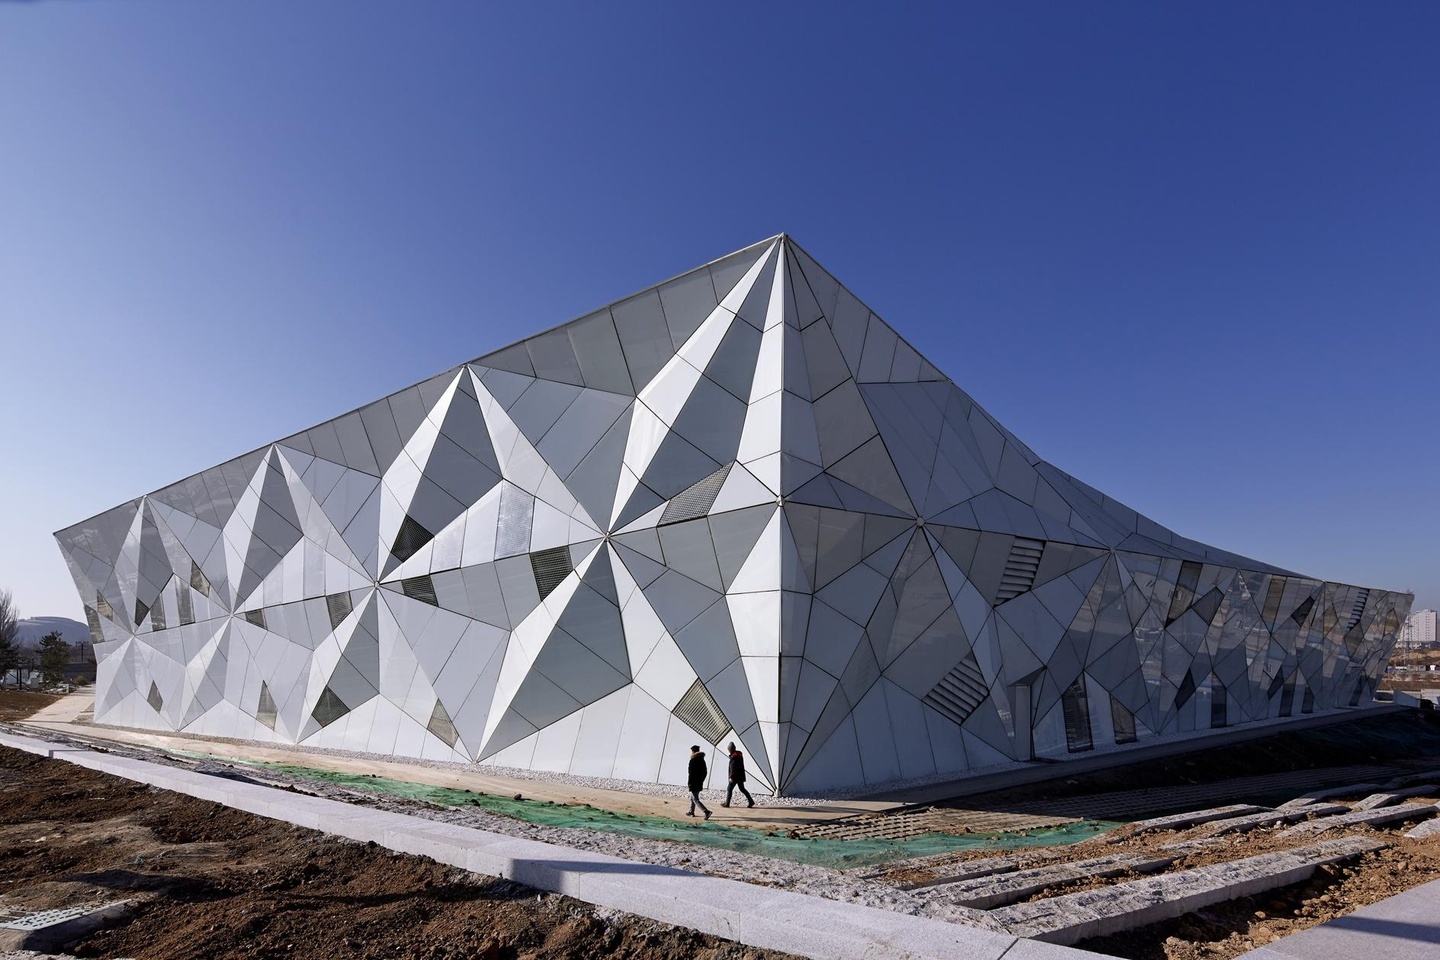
<box><xmin>0</xmin><ymin>0</ymin><xmax>1440</xmax><ymax>619</ymax></box>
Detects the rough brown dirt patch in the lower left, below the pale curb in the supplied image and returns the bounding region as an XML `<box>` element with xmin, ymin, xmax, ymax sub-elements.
<box><xmin>0</xmin><ymin>747</ymin><xmax>785</xmax><ymax>960</ymax></box>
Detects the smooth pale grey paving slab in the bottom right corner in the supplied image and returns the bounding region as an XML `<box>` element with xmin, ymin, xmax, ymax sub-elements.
<box><xmin>1240</xmin><ymin>881</ymin><xmax>1440</xmax><ymax>960</ymax></box>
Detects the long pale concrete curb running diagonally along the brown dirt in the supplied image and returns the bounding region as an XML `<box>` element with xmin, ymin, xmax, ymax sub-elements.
<box><xmin>0</xmin><ymin>733</ymin><xmax>1099</xmax><ymax>960</ymax></box>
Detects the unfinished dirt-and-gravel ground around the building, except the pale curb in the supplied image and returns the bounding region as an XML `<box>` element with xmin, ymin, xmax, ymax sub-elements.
<box><xmin>0</xmin><ymin>692</ymin><xmax>1440</xmax><ymax>960</ymax></box>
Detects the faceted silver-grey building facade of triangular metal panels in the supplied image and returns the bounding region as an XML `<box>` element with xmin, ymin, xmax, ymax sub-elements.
<box><xmin>56</xmin><ymin>236</ymin><xmax>1411</xmax><ymax>793</ymax></box>
